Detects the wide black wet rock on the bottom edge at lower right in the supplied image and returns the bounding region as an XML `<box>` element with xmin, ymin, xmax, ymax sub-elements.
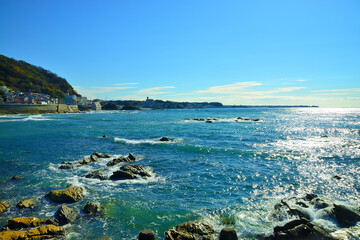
<box><xmin>265</xmin><ymin>219</ymin><xmax>335</xmax><ymax>240</ymax></box>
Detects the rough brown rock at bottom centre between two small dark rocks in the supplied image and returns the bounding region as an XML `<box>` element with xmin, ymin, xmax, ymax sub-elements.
<box><xmin>165</xmin><ymin>221</ymin><xmax>215</xmax><ymax>240</ymax></box>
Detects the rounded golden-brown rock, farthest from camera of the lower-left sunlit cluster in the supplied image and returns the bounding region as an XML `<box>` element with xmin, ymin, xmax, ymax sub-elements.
<box><xmin>46</xmin><ymin>186</ymin><xmax>84</xmax><ymax>203</ymax></box>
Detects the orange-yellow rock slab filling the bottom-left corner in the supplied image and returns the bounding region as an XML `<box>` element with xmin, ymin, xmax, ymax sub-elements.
<box><xmin>0</xmin><ymin>225</ymin><xmax>65</xmax><ymax>240</ymax></box>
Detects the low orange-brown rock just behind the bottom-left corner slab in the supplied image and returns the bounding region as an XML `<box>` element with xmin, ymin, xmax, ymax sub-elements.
<box><xmin>4</xmin><ymin>217</ymin><xmax>59</xmax><ymax>230</ymax></box>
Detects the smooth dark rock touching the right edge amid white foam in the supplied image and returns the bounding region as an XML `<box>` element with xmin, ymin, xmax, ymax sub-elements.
<box><xmin>331</xmin><ymin>204</ymin><xmax>360</xmax><ymax>228</ymax></box>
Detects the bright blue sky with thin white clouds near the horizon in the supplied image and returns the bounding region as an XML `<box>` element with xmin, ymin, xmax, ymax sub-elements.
<box><xmin>0</xmin><ymin>0</ymin><xmax>360</xmax><ymax>107</ymax></box>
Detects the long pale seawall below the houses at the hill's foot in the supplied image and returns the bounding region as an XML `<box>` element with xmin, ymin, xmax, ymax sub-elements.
<box><xmin>0</xmin><ymin>104</ymin><xmax>79</xmax><ymax>115</ymax></box>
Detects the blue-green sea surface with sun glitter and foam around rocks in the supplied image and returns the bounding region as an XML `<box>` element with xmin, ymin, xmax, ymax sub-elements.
<box><xmin>0</xmin><ymin>108</ymin><xmax>360</xmax><ymax>239</ymax></box>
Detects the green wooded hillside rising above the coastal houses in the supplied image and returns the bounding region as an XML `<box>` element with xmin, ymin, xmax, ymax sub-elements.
<box><xmin>0</xmin><ymin>55</ymin><xmax>79</xmax><ymax>99</ymax></box>
